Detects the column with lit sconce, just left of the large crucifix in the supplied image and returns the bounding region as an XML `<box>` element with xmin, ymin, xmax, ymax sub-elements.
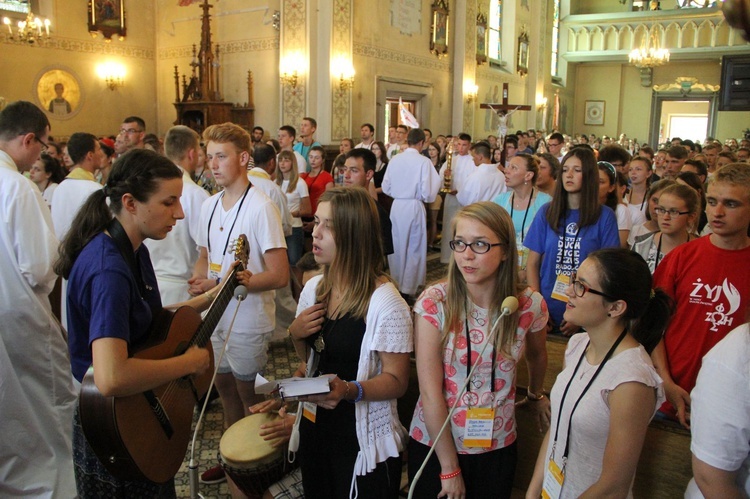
<box><xmin>451</xmin><ymin>0</ymin><xmax>477</xmax><ymax>135</ymax></box>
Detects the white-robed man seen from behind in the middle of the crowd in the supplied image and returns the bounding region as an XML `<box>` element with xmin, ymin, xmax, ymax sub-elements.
<box><xmin>382</xmin><ymin>128</ymin><xmax>440</xmax><ymax>295</ymax></box>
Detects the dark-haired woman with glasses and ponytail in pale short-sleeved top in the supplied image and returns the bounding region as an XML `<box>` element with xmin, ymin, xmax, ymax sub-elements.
<box><xmin>526</xmin><ymin>248</ymin><xmax>672</xmax><ymax>498</ymax></box>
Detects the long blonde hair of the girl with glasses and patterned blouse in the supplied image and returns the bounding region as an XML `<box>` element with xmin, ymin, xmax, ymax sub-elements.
<box><xmin>442</xmin><ymin>201</ymin><xmax>521</xmax><ymax>358</ymax></box>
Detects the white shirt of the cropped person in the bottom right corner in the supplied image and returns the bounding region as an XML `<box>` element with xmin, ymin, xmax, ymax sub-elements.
<box><xmin>685</xmin><ymin>324</ymin><xmax>750</xmax><ymax>499</ymax></box>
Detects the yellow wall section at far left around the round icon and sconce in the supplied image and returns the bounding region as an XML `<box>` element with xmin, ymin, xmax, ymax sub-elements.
<box><xmin>0</xmin><ymin>0</ymin><xmax>156</xmax><ymax>138</ymax></box>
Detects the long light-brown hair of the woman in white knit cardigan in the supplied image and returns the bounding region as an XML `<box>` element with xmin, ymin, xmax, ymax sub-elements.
<box><xmin>315</xmin><ymin>187</ymin><xmax>387</xmax><ymax>319</ymax></box>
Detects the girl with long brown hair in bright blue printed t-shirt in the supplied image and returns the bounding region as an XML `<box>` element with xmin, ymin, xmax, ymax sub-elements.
<box><xmin>523</xmin><ymin>146</ymin><xmax>620</xmax><ymax>336</ymax></box>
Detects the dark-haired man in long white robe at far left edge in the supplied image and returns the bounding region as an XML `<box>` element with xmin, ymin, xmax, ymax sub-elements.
<box><xmin>0</xmin><ymin>101</ymin><xmax>76</xmax><ymax>498</ymax></box>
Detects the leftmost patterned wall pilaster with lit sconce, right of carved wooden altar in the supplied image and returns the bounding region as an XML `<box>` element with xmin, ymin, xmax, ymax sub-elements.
<box><xmin>279</xmin><ymin>0</ymin><xmax>310</xmax><ymax>128</ymax></box>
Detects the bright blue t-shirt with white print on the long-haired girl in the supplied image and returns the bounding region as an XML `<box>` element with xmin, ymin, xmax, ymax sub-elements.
<box><xmin>524</xmin><ymin>204</ymin><xmax>620</xmax><ymax>325</ymax></box>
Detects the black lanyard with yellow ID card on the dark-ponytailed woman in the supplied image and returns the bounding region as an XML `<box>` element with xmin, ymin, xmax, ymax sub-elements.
<box><xmin>542</xmin><ymin>328</ymin><xmax>628</xmax><ymax>499</ymax></box>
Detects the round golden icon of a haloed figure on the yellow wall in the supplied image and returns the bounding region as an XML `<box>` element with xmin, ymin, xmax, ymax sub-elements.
<box><xmin>34</xmin><ymin>67</ymin><xmax>83</xmax><ymax>120</ymax></box>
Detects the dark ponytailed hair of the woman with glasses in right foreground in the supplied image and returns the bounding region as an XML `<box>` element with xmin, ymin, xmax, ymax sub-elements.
<box><xmin>588</xmin><ymin>248</ymin><xmax>674</xmax><ymax>354</ymax></box>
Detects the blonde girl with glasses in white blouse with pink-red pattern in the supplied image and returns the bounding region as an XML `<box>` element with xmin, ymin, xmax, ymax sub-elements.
<box><xmin>408</xmin><ymin>202</ymin><xmax>549</xmax><ymax>498</ymax></box>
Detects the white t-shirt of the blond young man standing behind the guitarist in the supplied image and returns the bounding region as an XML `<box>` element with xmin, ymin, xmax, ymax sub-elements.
<box><xmin>198</xmin><ymin>187</ymin><xmax>286</xmax><ymax>333</ymax></box>
